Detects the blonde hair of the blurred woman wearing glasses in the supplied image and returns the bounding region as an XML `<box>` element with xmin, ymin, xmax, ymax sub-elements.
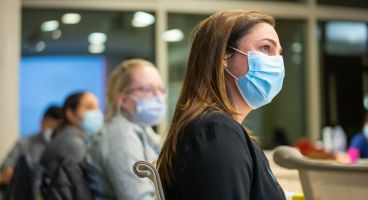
<box><xmin>106</xmin><ymin>58</ymin><xmax>154</xmax><ymax>121</ymax></box>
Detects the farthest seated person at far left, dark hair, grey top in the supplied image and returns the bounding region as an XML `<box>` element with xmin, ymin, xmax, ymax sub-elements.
<box><xmin>0</xmin><ymin>106</ymin><xmax>62</xmax><ymax>185</ymax></box>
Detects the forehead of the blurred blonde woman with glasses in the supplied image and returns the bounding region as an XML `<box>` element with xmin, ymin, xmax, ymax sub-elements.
<box><xmin>131</xmin><ymin>65</ymin><xmax>163</xmax><ymax>86</ymax></box>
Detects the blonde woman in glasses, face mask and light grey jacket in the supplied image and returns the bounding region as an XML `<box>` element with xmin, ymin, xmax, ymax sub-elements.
<box><xmin>85</xmin><ymin>59</ymin><xmax>166</xmax><ymax>200</ymax></box>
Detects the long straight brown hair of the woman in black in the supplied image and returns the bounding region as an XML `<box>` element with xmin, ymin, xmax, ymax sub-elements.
<box><xmin>158</xmin><ymin>11</ymin><xmax>275</xmax><ymax>187</ymax></box>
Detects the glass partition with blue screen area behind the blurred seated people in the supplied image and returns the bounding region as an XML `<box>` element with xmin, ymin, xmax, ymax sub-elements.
<box><xmin>20</xmin><ymin>8</ymin><xmax>156</xmax><ymax>136</ymax></box>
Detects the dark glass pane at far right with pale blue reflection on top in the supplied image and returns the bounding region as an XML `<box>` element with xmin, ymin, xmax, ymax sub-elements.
<box><xmin>319</xmin><ymin>21</ymin><xmax>368</xmax><ymax>141</ymax></box>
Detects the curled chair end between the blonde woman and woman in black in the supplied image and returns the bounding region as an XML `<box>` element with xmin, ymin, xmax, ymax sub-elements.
<box><xmin>133</xmin><ymin>161</ymin><xmax>165</xmax><ymax>200</ymax></box>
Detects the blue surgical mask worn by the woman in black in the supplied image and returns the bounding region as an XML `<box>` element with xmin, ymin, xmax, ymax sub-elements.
<box><xmin>225</xmin><ymin>47</ymin><xmax>285</xmax><ymax>109</ymax></box>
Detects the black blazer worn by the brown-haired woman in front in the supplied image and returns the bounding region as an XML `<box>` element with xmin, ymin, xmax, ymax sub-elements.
<box><xmin>164</xmin><ymin>112</ymin><xmax>285</xmax><ymax>200</ymax></box>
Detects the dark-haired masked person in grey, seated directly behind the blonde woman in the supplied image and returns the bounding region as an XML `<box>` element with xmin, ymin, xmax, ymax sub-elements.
<box><xmin>40</xmin><ymin>92</ymin><xmax>104</xmax><ymax>176</ymax></box>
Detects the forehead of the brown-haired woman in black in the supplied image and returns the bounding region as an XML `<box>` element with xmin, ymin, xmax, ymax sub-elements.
<box><xmin>239</xmin><ymin>23</ymin><xmax>281</xmax><ymax>48</ymax></box>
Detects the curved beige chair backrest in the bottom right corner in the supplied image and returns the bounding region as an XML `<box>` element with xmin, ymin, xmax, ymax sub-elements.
<box><xmin>273</xmin><ymin>146</ymin><xmax>368</xmax><ymax>200</ymax></box>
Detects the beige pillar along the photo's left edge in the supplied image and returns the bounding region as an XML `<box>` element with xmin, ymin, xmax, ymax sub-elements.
<box><xmin>0</xmin><ymin>0</ymin><xmax>21</xmax><ymax>162</ymax></box>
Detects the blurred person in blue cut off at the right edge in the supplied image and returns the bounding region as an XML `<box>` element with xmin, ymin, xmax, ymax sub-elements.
<box><xmin>347</xmin><ymin>112</ymin><xmax>368</xmax><ymax>163</ymax></box>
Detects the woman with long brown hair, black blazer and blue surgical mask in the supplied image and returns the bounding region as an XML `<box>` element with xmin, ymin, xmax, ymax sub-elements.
<box><xmin>158</xmin><ymin>11</ymin><xmax>285</xmax><ymax>200</ymax></box>
